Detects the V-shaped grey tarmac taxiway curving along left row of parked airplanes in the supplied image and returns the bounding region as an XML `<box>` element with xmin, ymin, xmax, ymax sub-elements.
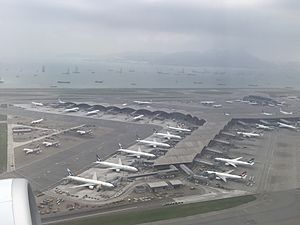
<box><xmin>8</xmin><ymin>107</ymin><xmax>158</xmax><ymax>190</ymax></box>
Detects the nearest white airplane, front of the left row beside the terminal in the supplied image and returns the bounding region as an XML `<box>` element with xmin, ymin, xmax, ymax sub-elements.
<box><xmin>66</xmin><ymin>169</ymin><xmax>114</xmax><ymax>189</ymax></box>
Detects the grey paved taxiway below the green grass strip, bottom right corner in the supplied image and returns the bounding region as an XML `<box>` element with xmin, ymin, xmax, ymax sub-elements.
<box><xmin>143</xmin><ymin>189</ymin><xmax>300</xmax><ymax>225</ymax></box>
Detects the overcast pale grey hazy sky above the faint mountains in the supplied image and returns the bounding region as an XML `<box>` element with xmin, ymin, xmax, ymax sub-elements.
<box><xmin>0</xmin><ymin>0</ymin><xmax>300</xmax><ymax>61</ymax></box>
